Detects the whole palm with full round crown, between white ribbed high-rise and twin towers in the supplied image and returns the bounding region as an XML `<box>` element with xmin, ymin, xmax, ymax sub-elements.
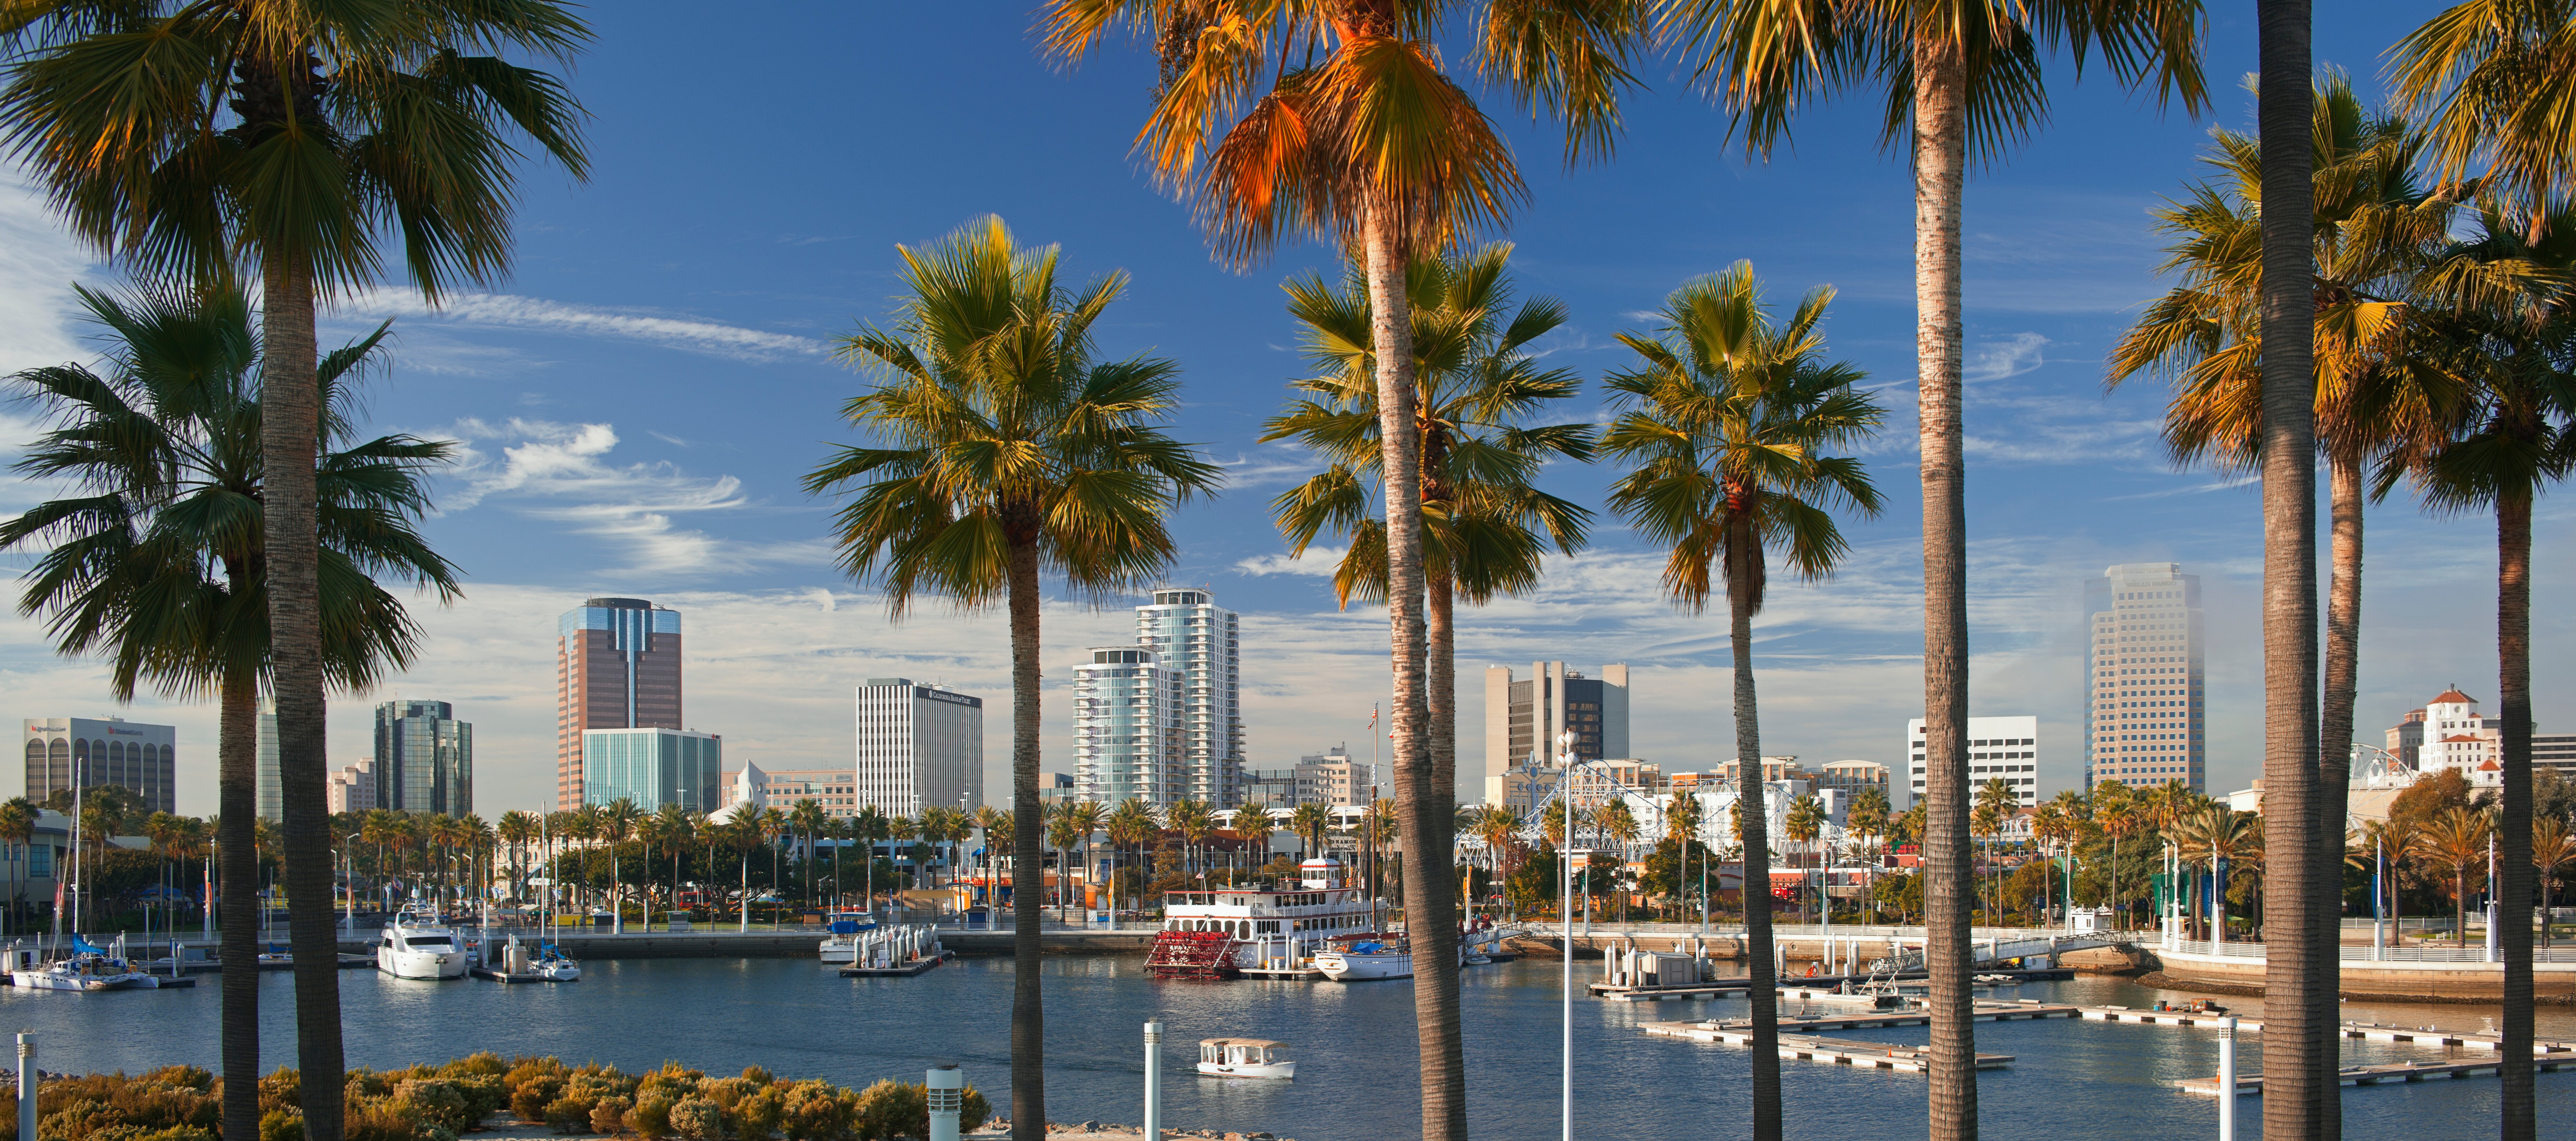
<box><xmin>806</xmin><ymin>219</ymin><xmax>1218</xmax><ymax>1120</ymax></box>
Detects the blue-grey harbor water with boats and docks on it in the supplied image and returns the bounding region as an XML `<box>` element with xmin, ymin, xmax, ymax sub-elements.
<box><xmin>15</xmin><ymin>958</ymin><xmax>2576</xmax><ymax>1141</ymax></box>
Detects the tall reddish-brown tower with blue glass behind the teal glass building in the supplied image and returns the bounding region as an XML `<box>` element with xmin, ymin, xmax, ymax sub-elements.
<box><xmin>554</xmin><ymin>597</ymin><xmax>680</xmax><ymax>811</ymax></box>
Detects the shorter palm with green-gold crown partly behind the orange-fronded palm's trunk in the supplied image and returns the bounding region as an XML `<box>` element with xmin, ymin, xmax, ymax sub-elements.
<box><xmin>1262</xmin><ymin>242</ymin><xmax>1595</xmax><ymax>829</ymax></box>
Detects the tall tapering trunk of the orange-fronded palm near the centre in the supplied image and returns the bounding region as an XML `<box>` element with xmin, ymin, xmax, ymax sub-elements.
<box><xmin>1370</xmin><ymin>201</ymin><xmax>1466</xmax><ymax>1141</ymax></box>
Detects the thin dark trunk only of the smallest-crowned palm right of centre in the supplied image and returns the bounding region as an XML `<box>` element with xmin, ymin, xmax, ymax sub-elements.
<box><xmin>1726</xmin><ymin>533</ymin><xmax>1780</xmax><ymax>1141</ymax></box>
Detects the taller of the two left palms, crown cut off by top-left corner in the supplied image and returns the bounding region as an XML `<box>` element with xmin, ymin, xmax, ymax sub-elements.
<box><xmin>0</xmin><ymin>13</ymin><xmax>590</xmax><ymax>1141</ymax></box>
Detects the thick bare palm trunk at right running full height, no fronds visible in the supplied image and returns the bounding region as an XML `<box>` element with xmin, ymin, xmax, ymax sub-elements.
<box><xmin>2256</xmin><ymin>0</ymin><xmax>2336</xmax><ymax>1141</ymax></box>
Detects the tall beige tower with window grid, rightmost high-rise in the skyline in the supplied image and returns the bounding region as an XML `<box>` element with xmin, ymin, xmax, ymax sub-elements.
<box><xmin>2081</xmin><ymin>562</ymin><xmax>2208</xmax><ymax>793</ymax></box>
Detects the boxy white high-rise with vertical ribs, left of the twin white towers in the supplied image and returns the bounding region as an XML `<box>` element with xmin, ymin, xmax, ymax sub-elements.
<box><xmin>860</xmin><ymin>677</ymin><xmax>984</xmax><ymax>819</ymax></box>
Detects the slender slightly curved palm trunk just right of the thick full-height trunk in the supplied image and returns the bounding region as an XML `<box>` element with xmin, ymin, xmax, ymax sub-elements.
<box><xmin>2308</xmin><ymin>456</ymin><xmax>2362</xmax><ymax>1141</ymax></box>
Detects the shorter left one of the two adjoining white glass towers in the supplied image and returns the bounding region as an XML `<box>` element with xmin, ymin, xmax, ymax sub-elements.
<box><xmin>1074</xmin><ymin>647</ymin><xmax>1188</xmax><ymax>806</ymax></box>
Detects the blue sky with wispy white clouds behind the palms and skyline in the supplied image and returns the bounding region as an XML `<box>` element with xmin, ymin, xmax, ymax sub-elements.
<box><xmin>0</xmin><ymin>0</ymin><xmax>2576</xmax><ymax>816</ymax></box>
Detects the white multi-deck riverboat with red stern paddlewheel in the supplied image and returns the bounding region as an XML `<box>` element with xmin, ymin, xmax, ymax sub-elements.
<box><xmin>1146</xmin><ymin>855</ymin><xmax>1378</xmax><ymax>979</ymax></box>
